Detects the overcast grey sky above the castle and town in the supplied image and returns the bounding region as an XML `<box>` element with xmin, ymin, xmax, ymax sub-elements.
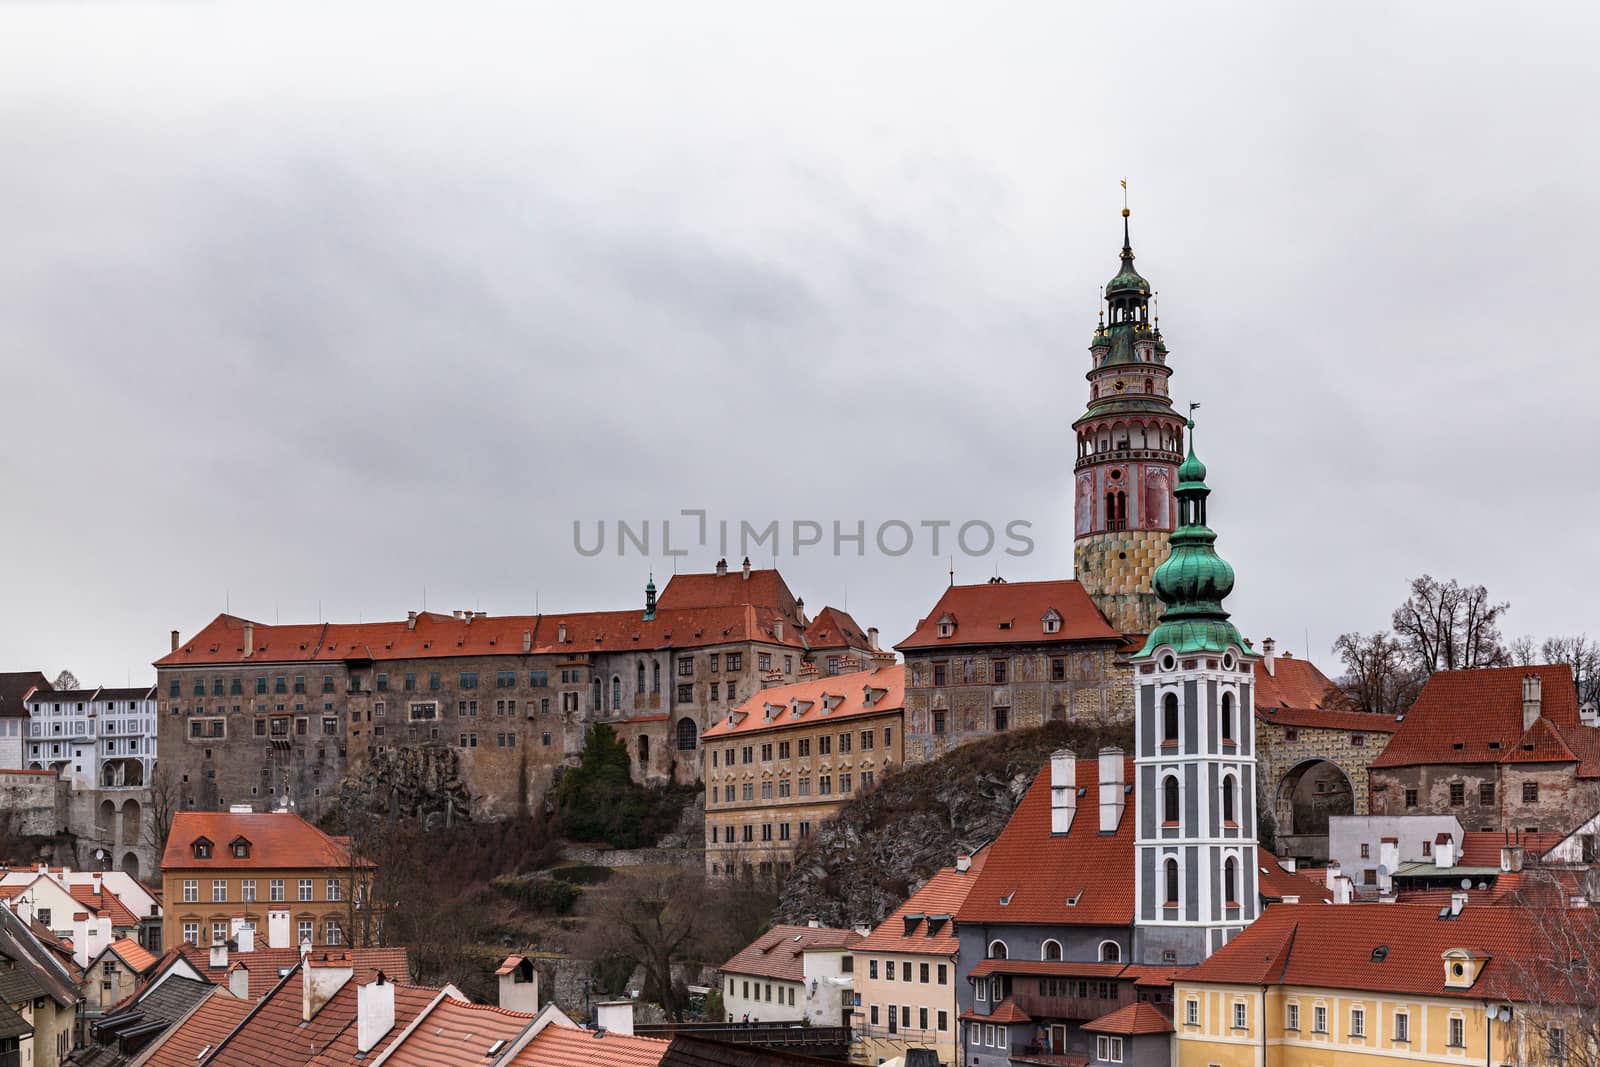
<box><xmin>0</xmin><ymin>3</ymin><xmax>1600</xmax><ymax>685</ymax></box>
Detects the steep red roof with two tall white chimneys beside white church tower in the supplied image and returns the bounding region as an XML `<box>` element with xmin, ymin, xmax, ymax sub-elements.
<box><xmin>955</xmin><ymin>757</ymin><xmax>1134</xmax><ymax>926</ymax></box>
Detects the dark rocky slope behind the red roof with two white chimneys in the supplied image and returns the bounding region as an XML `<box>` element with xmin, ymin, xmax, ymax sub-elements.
<box><xmin>774</xmin><ymin>723</ymin><xmax>1133</xmax><ymax>926</ymax></box>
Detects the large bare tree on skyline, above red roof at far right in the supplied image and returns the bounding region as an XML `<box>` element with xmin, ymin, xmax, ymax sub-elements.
<box><xmin>1394</xmin><ymin>574</ymin><xmax>1510</xmax><ymax>673</ymax></box>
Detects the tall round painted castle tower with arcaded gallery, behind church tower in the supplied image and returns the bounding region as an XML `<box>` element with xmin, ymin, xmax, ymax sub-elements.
<box><xmin>1072</xmin><ymin>208</ymin><xmax>1184</xmax><ymax>633</ymax></box>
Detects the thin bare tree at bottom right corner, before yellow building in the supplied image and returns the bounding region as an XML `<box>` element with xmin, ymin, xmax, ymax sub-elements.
<box><xmin>1490</xmin><ymin>869</ymin><xmax>1600</xmax><ymax>1067</ymax></box>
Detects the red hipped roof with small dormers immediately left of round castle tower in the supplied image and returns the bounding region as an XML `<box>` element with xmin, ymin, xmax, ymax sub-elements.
<box><xmin>896</xmin><ymin>581</ymin><xmax>1123</xmax><ymax>651</ymax></box>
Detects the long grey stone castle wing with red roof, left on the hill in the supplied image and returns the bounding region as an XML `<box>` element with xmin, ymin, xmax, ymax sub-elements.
<box><xmin>155</xmin><ymin>560</ymin><xmax>883</xmax><ymax>816</ymax></box>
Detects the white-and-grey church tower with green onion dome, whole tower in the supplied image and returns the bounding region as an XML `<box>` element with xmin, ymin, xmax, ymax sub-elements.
<box><xmin>1130</xmin><ymin>421</ymin><xmax>1261</xmax><ymax>965</ymax></box>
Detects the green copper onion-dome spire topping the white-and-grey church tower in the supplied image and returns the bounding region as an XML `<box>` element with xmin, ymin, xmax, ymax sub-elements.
<box><xmin>1139</xmin><ymin>405</ymin><xmax>1250</xmax><ymax>656</ymax></box>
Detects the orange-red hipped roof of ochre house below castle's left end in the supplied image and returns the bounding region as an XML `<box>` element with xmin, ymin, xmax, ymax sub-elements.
<box><xmin>162</xmin><ymin>811</ymin><xmax>350</xmax><ymax>872</ymax></box>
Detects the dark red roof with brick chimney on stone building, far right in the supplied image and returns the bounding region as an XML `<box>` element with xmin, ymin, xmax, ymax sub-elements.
<box><xmin>1373</xmin><ymin>664</ymin><xmax>1600</xmax><ymax>777</ymax></box>
